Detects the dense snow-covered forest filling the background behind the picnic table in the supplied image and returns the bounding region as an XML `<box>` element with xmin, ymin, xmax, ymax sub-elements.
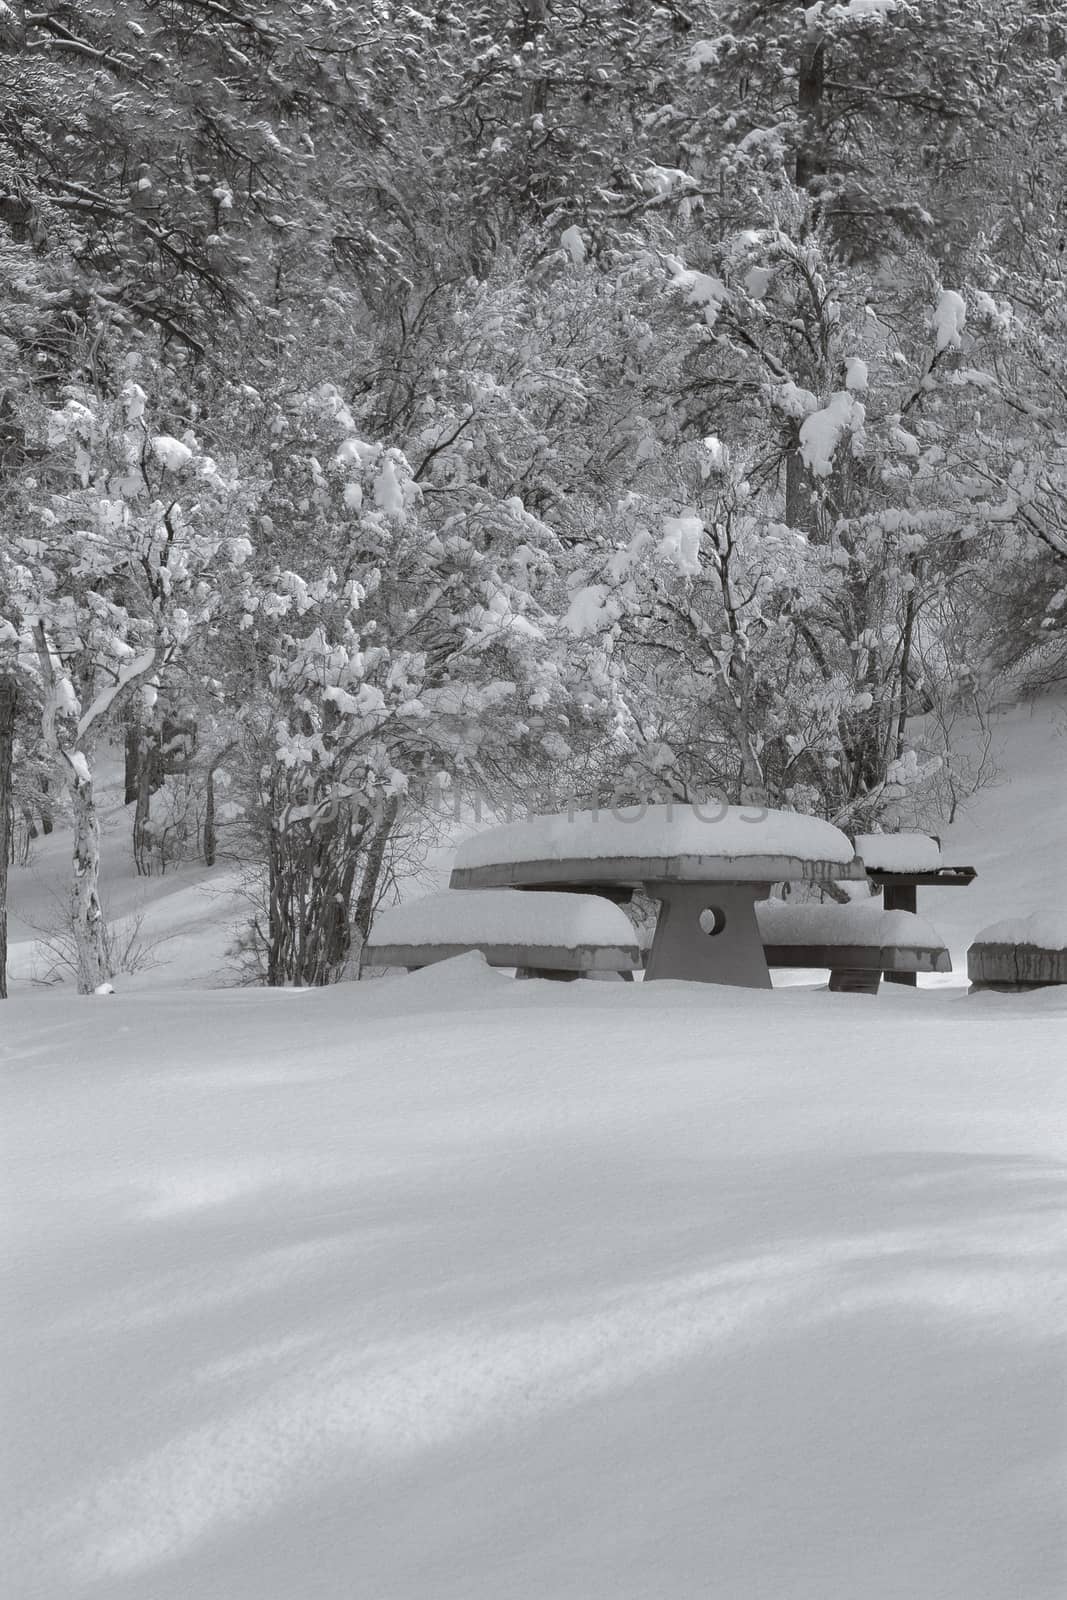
<box><xmin>0</xmin><ymin>0</ymin><xmax>1067</xmax><ymax>990</ymax></box>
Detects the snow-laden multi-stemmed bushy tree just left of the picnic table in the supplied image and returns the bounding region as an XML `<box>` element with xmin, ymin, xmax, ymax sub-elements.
<box><xmin>228</xmin><ymin>386</ymin><xmax>588</xmax><ymax>984</ymax></box>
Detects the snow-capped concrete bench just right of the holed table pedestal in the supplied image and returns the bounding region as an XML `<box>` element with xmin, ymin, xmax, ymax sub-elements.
<box><xmin>757</xmin><ymin>899</ymin><xmax>952</xmax><ymax>994</ymax></box>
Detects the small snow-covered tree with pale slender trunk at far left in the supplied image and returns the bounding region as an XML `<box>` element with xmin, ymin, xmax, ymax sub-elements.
<box><xmin>0</xmin><ymin>378</ymin><xmax>251</xmax><ymax>992</ymax></box>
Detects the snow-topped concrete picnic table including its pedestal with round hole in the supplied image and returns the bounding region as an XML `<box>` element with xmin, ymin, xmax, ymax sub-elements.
<box><xmin>450</xmin><ymin>802</ymin><xmax>865</xmax><ymax>989</ymax></box>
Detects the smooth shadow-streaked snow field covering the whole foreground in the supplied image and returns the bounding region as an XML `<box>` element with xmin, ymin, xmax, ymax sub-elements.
<box><xmin>0</xmin><ymin>957</ymin><xmax>1067</xmax><ymax>1600</ymax></box>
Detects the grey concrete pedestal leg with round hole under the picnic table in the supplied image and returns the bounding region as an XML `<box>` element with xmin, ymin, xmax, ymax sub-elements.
<box><xmin>645</xmin><ymin>883</ymin><xmax>771</xmax><ymax>989</ymax></box>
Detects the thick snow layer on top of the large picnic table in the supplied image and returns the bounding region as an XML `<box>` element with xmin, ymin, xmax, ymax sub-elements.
<box><xmin>456</xmin><ymin>800</ymin><xmax>854</xmax><ymax>869</ymax></box>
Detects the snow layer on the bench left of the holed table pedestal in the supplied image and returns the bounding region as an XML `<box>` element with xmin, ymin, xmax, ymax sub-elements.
<box><xmin>368</xmin><ymin>890</ymin><xmax>637</xmax><ymax>949</ymax></box>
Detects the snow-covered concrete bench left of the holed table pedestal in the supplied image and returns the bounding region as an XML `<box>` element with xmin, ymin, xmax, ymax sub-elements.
<box><xmin>363</xmin><ymin>890</ymin><xmax>641</xmax><ymax>978</ymax></box>
